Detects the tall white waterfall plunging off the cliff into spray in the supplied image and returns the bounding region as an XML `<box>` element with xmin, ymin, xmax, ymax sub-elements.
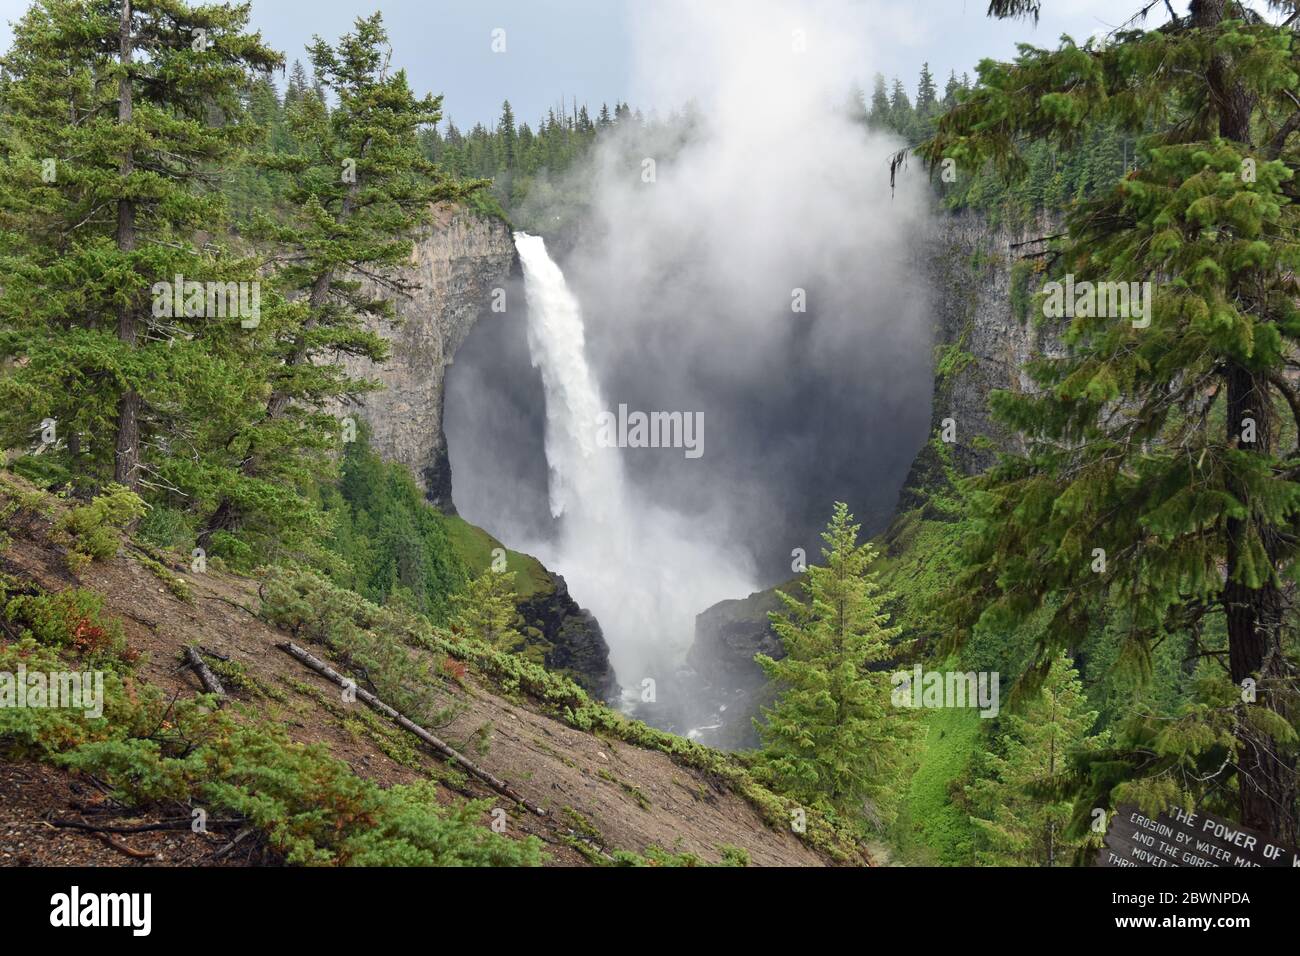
<box><xmin>515</xmin><ymin>233</ymin><xmax>757</xmax><ymax>701</ymax></box>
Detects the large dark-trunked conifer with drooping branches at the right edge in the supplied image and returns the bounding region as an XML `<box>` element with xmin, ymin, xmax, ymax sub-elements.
<box><xmin>922</xmin><ymin>0</ymin><xmax>1300</xmax><ymax>842</ymax></box>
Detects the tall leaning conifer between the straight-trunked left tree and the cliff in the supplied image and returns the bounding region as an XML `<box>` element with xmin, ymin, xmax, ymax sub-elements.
<box><xmin>200</xmin><ymin>13</ymin><xmax>481</xmax><ymax>554</ymax></box>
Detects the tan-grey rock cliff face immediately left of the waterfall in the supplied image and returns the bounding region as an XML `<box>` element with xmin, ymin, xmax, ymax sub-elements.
<box><xmin>345</xmin><ymin>204</ymin><xmax>517</xmax><ymax>514</ymax></box>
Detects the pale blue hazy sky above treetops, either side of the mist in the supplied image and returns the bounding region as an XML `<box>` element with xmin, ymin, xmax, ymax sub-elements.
<box><xmin>0</xmin><ymin>0</ymin><xmax>1186</xmax><ymax>126</ymax></box>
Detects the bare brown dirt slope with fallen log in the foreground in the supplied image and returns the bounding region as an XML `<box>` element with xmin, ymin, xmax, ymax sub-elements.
<box><xmin>0</xmin><ymin>489</ymin><xmax>829</xmax><ymax>866</ymax></box>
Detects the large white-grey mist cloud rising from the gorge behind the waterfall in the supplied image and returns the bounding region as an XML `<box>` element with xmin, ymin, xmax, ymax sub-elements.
<box><xmin>446</xmin><ymin>3</ymin><xmax>931</xmax><ymax>687</ymax></box>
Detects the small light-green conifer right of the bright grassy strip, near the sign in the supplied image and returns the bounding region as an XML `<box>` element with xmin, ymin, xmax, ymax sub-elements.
<box><xmin>966</xmin><ymin>654</ymin><xmax>1102</xmax><ymax>866</ymax></box>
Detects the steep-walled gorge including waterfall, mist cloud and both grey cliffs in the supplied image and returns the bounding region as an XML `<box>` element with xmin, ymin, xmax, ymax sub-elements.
<box><xmin>312</xmin><ymin>0</ymin><xmax>1050</xmax><ymax>747</ymax></box>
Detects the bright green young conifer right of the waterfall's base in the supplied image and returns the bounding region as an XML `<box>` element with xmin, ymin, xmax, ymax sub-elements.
<box><xmin>754</xmin><ymin>503</ymin><xmax>906</xmax><ymax>826</ymax></box>
